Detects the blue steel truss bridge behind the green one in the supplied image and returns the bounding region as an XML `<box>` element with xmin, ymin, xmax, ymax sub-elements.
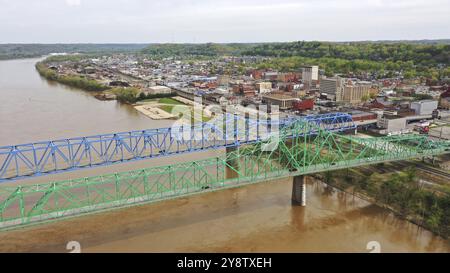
<box><xmin>0</xmin><ymin>113</ymin><xmax>356</xmax><ymax>182</ymax></box>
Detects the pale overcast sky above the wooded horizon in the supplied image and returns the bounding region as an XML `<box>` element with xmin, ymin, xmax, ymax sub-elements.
<box><xmin>0</xmin><ymin>0</ymin><xmax>450</xmax><ymax>43</ymax></box>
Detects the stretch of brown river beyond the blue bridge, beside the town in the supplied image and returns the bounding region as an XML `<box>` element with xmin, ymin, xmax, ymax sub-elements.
<box><xmin>0</xmin><ymin>56</ymin><xmax>172</xmax><ymax>145</ymax></box>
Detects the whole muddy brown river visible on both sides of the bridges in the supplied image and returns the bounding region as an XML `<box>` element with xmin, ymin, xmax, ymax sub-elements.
<box><xmin>0</xmin><ymin>59</ymin><xmax>450</xmax><ymax>252</ymax></box>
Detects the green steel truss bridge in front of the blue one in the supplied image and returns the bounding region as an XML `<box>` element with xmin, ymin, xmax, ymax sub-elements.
<box><xmin>0</xmin><ymin>120</ymin><xmax>450</xmax><ymax>228</ymax></box>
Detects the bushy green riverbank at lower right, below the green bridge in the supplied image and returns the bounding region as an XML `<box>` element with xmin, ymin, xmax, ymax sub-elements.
<box><xmin>320</xmin><ymin>163</ymin><xmax>450</xmax><ymax>238</ymax></box>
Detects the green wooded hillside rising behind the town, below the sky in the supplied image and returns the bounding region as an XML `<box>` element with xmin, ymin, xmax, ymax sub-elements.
<box><xmin>142</xmin><ymin>41</ymin><xmax>450</xmax><ymax>81</ymax></box>
